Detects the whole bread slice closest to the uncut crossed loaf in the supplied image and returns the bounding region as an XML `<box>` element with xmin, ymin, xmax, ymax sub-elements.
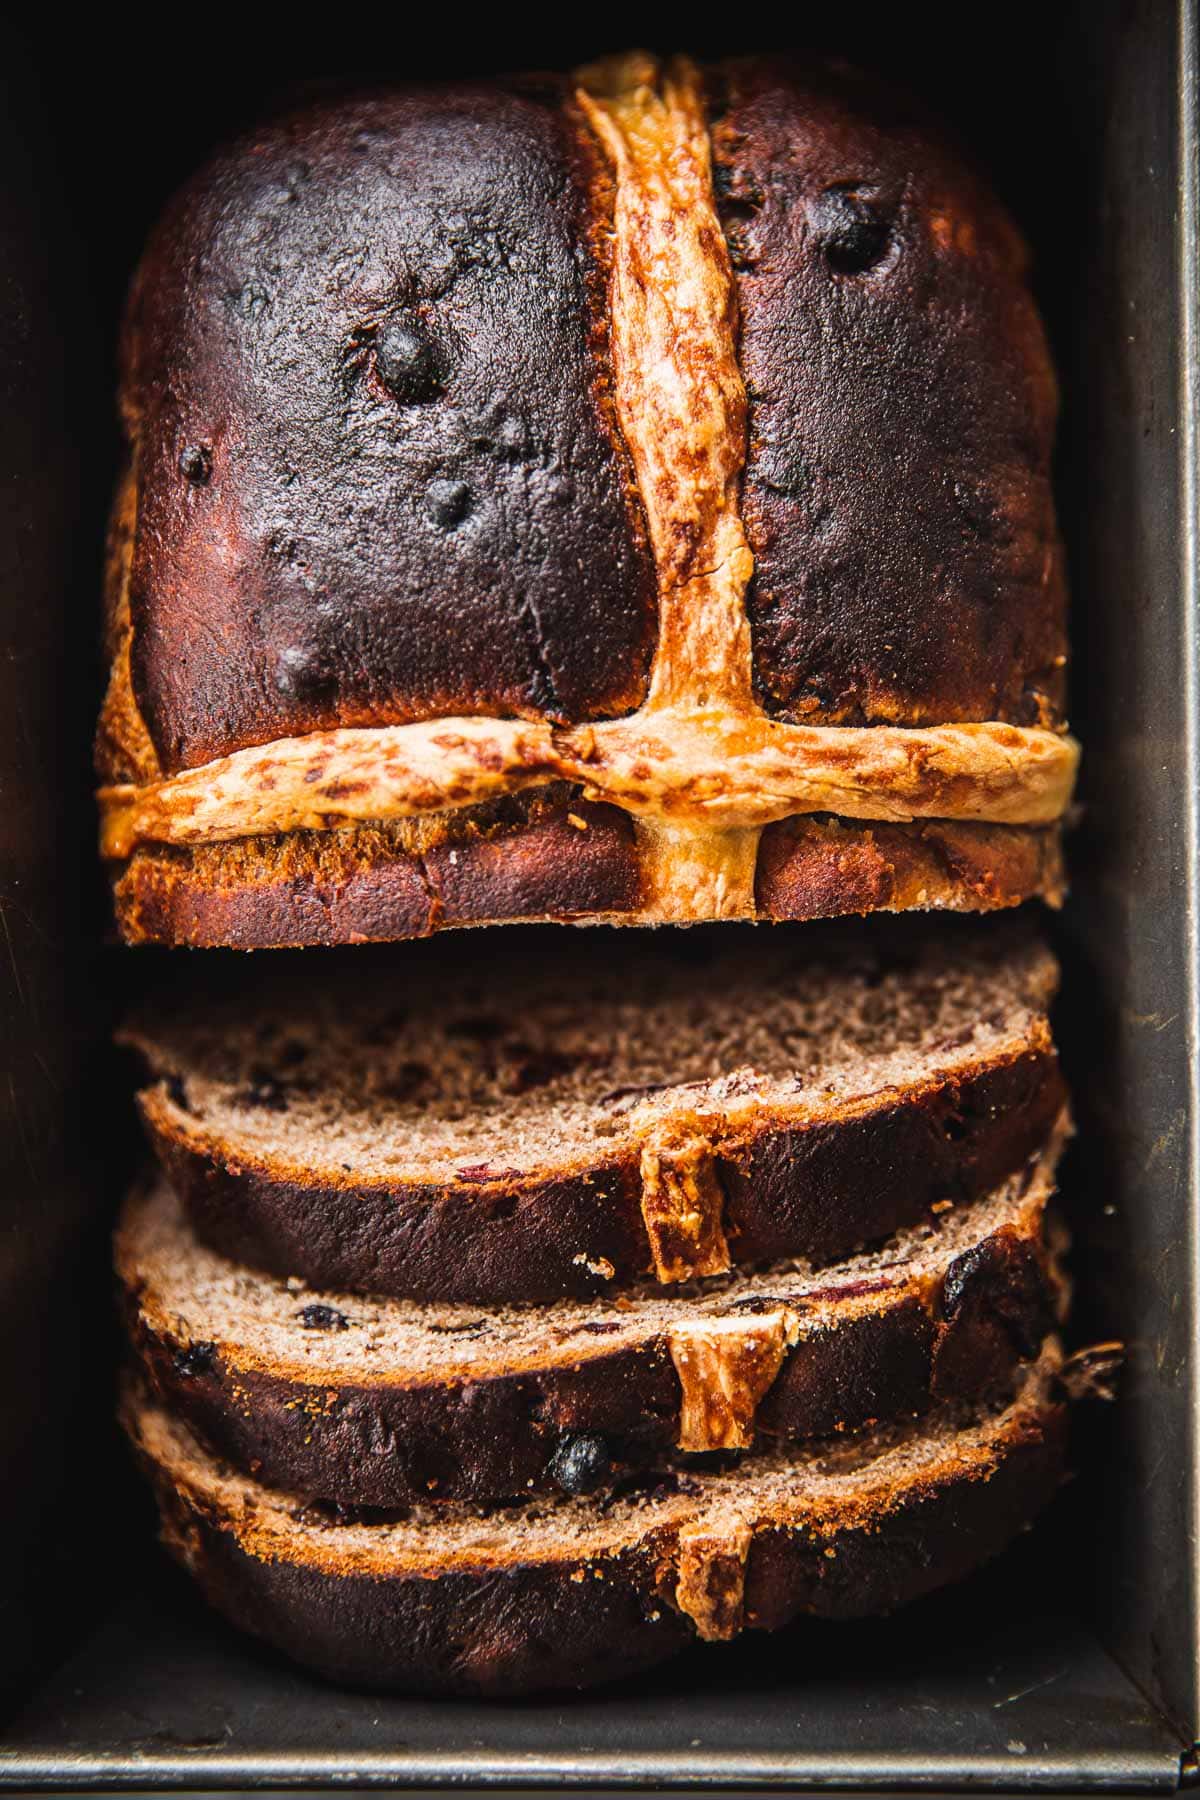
<box><xmin>124</xmin><ymin>922</ymin><xmax>1063</xmax><ymax>1305</ymax></box>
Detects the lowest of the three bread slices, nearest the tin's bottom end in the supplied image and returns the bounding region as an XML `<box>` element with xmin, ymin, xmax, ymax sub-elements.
<box><xmin>124</xmin><ymin>1350</ymin><xmax>1065</xmax><ymax>1694</ymax></box>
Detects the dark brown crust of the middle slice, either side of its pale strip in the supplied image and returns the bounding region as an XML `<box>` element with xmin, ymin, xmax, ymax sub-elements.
<box><xmin>126</xmin><ymin>1202</ymin><xmax>1054</xmax><ymax>1508</ymax></box>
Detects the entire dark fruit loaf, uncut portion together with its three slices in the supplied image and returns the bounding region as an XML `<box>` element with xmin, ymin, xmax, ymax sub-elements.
<box><xmin>97</xmin><ymin>54</ymin><xmax>1078</xmax><ymax>1696</ymax></box>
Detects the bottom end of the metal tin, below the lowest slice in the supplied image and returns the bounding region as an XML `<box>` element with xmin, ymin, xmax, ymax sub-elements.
<box><xmin>0</xmin><ymin>1537</ymin><xmax>1180</xmax><ymax>1793</ymax></box>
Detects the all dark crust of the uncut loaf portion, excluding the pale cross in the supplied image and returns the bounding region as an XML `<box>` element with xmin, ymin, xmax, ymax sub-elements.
<box><xmin>101</xmin><ymin>49</ymin><xmax>1065</xmax><ymax>949</ymax></box>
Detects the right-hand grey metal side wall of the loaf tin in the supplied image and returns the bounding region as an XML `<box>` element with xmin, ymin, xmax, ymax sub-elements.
<box><xmin>1060</xmin><ymin>4</ymin><xmax>1200</xmax><ymax>1737</ymax></box>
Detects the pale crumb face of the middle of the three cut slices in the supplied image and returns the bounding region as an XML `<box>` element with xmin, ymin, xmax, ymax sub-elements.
<box><xmin>117</xmin><ymin>1134</ymin><xmax>1061</xmax><ymax>1388</ymax></box>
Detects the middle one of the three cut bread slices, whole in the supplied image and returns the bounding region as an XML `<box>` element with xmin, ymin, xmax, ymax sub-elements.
<box><xmin>117</xmin><ymin>1147</ymin><xmax>1061</xmax><ymax>1507</ymax></box>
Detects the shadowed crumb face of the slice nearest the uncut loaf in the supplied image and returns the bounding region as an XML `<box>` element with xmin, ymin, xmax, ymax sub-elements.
<box><xmin>124</xmin><ymin>927</ymin><xmax>1056</xmax><ymax>1186</ymax></box>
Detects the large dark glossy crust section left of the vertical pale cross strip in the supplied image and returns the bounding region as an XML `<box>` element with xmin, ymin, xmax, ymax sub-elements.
<box><xmin>112</xmin><ymin>77</ymin><xmax>657</xmax><ymax>772</ymax></box>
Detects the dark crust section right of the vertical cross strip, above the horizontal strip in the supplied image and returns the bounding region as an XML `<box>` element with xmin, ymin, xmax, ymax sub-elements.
<box><xmin>711</xmin><ymin>59</ymin><xmax>1067</xmax><ymax>725</ymax></box>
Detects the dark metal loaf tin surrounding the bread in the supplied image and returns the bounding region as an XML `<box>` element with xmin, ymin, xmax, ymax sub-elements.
<box><xmin>0</xmin><ymin>0</ymin><xmax>1200</xmax><ymax>1793</ymax></box>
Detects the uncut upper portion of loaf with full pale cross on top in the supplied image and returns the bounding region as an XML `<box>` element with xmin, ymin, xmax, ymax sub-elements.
<box><xmin>99</xmin><ymin>56</ymin><xmax>1076</xmax><ymax>947</ymax></box>
